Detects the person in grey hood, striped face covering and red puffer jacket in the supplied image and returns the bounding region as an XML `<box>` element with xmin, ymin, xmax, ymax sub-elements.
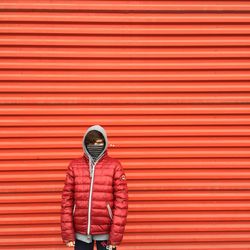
<box><xmin>61</xmin><ymin>125</ymin><xmax>128</xmax><ymax>250</ymax></box>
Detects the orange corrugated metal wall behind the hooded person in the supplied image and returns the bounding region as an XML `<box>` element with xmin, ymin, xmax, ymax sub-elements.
<box><xmin>0</xmin><ymin>0</ymin><xmax>250</xmax><ymax>250</ymax></box>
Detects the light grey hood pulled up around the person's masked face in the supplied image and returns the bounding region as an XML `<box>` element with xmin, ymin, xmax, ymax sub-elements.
<box><xmin>82</xmin><ymin>124</ymin><xmax>108</xmax><ymax>164</ymax></box>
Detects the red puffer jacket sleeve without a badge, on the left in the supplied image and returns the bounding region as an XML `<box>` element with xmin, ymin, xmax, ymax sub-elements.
<box><xmin>61</xmin><ymin>161</ymin><xmax>75</xmax><ymax>243</ymax></box>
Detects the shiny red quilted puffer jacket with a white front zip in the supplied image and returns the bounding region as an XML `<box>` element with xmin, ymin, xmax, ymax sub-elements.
<box><xmin>61</xmin><ymin>150</ymin><xmax>128</xmax><ymax>245</ymax></box>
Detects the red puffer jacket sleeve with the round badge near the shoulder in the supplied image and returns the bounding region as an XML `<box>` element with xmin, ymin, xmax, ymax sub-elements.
<box><xmin>108</xmin><ymin>161</ymin><xmax>128</xmax><ymax>245</ymax></box>
